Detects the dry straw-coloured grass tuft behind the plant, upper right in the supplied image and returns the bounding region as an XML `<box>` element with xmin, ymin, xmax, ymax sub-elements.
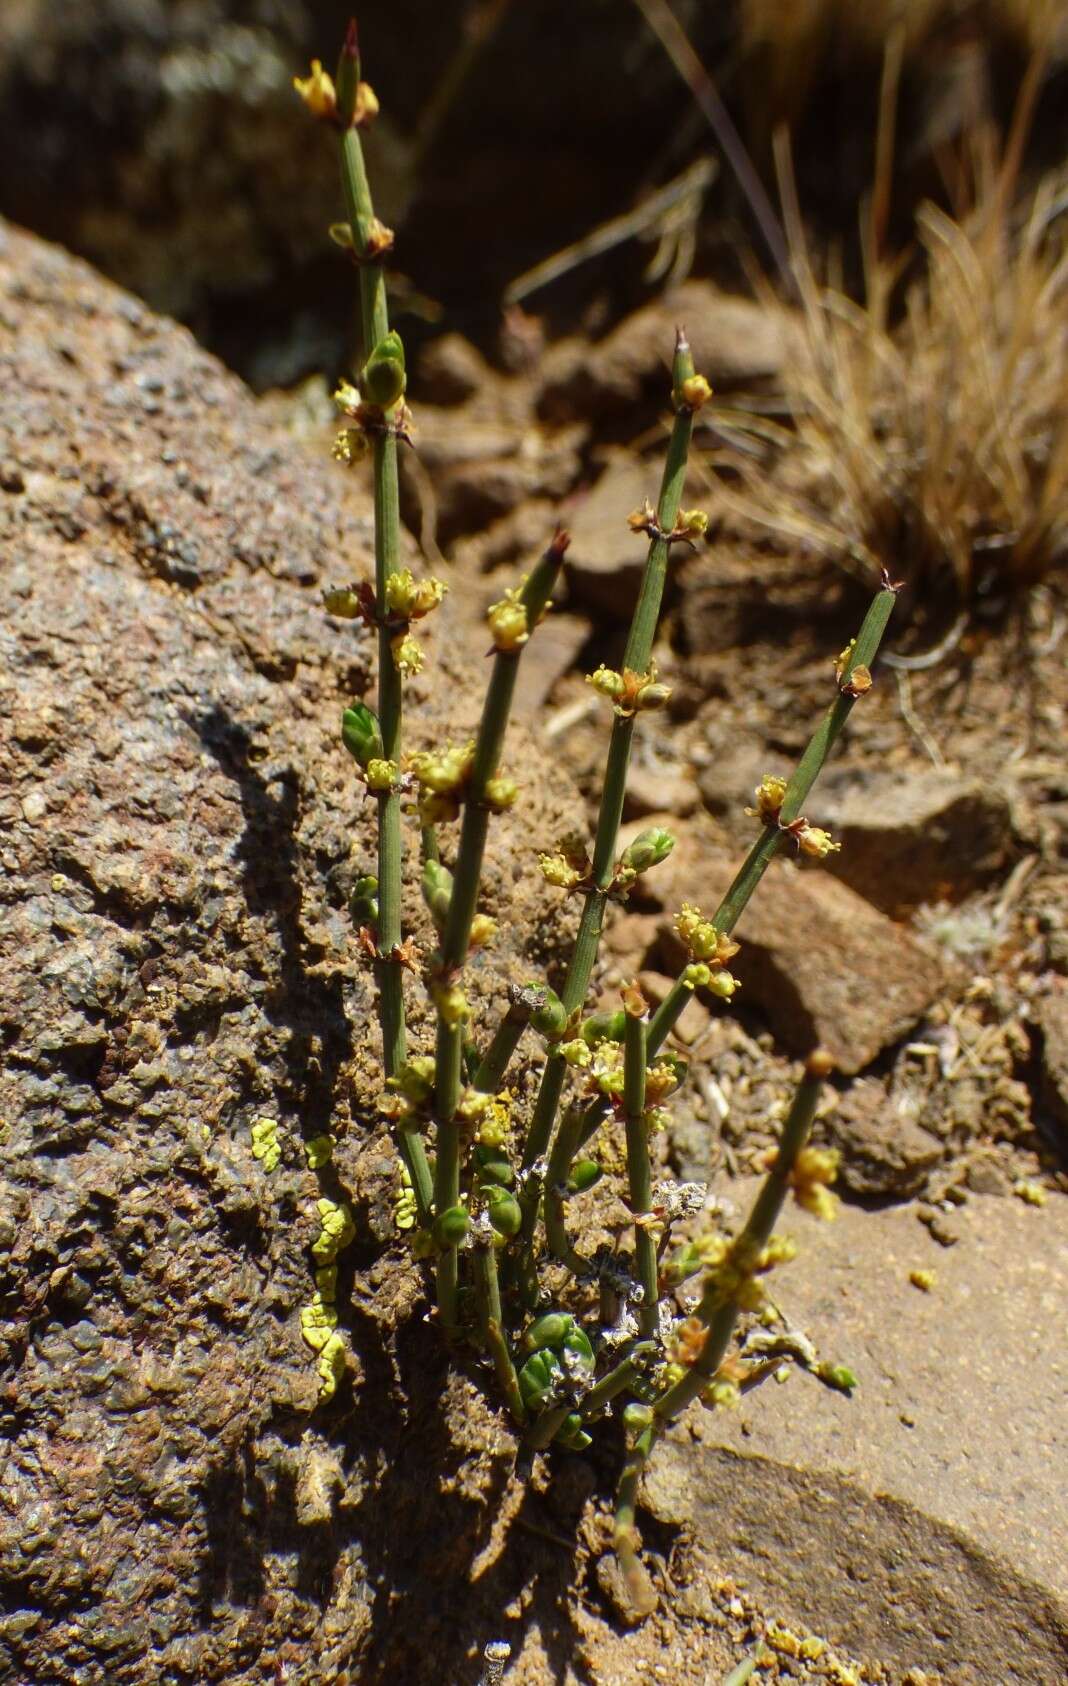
<box><xmin>715</xmin><ymin>159</ymin><xmax>1068</xmax><ymax>604</ymax></box>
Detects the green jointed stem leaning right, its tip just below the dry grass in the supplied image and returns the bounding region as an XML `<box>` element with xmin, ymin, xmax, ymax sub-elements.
<box><xmin>650</xmin><ymin>590</ymin><xmax>896</xmax><ymax>1057</ymax></box>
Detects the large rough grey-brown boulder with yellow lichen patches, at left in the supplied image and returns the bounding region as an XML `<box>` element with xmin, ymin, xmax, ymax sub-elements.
<box><xmin>0</xmin><ymin>220</ymin><xmax>564</xmax><ymax>1686</ymax></box>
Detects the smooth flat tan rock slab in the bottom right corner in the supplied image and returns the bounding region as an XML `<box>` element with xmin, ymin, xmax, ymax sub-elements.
<box><xmin>645</xmin><ymin>1184</ymin><xmax>1068</xmax><ymax>1686</ymax></box>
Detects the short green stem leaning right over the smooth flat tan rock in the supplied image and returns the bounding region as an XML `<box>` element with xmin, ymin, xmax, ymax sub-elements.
<box><xmin>616</xmin><ymin>1052</ymin><xmax>832</xmax><ymax>1570</ymax></box>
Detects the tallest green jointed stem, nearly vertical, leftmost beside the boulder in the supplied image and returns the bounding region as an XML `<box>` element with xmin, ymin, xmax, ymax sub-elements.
<box><xmin>339</xmin><ymin>49</ymin><xmax>432</xmax><ymax>1222</ymax></box>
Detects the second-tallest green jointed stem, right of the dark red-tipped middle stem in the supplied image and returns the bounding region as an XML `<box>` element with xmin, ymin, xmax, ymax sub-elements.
<box><xmin>523</xmin><ymin>329</ymin><xmax>693</xmax><ymax>1173</ymax></box>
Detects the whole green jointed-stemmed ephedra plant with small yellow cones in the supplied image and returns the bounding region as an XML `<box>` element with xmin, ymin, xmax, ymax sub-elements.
<box><xmin>297</xmin><ymin>25</ymin><xmax>894</xmax><ymax>1608</ymax></box>
